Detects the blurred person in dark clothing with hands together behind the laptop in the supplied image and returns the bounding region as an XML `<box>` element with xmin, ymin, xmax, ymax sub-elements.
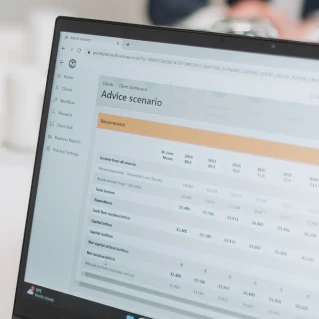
<box><xmin>149</xmin><ymin>0</ymin><xmax>319</xmax><ymax>41</ymax></box>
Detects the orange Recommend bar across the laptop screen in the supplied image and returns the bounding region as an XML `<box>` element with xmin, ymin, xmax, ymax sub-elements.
<box><xmin>98</xmin><ymin>113</ymin><xmax>319</xmax><ymax>165</ymax></box>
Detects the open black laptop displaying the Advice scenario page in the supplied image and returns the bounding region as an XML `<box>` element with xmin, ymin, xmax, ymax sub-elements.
<box><xmin>13</xmin><ymin>17</ymin><xmax>319</xmax><ymax>319</ymax></box>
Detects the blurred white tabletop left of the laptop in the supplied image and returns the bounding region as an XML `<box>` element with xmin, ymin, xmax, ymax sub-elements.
<box><xmin>0</xmin><ymin>148</ymin><xmax>34</xmax><ymax>319</ymax></box>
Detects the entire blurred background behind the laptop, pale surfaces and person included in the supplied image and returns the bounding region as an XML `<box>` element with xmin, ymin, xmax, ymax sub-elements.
<box><xmin>0</xmin><ymin>0</ymin><xmax>319</xmax><ymax>318</ymax></box>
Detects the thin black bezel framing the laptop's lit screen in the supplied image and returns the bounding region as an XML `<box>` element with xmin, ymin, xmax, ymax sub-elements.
<box><xmin>13</xmin><ymin>17</ymin><xmax>319</xmax><ymax>319</ymax></box>
